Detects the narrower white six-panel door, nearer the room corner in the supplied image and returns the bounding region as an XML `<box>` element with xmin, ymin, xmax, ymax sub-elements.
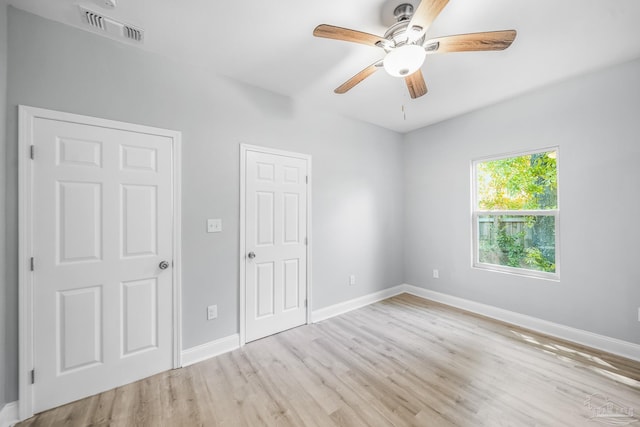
<box><xmin>244</xmin><ymin>149</ymin><xmax>309</xmax><ymax>342</ymax></box>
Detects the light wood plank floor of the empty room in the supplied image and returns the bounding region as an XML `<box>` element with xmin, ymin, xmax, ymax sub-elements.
<box><xmin>19</xmin><ymin>294</ymin><xmax>640</xmax><ymax>427</ymax></box>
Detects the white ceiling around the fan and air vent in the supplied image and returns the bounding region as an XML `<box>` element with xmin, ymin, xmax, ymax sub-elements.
<box><xmin>8</xmin><ymin>0</ymin><xmax>640</xmax><ymax>132</ymax></box>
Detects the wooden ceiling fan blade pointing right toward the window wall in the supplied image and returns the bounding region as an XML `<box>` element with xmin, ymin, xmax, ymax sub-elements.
<box><xmin>425</xmin><ymin>30</ymin><xmax>516</xmax><ymax>53</ymax></box>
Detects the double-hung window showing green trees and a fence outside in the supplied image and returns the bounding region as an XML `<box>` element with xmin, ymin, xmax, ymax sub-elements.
<box><xmin>472</xmin><ymin>148</ymin><xmax>559</xmax><ymax>279</ymax></box>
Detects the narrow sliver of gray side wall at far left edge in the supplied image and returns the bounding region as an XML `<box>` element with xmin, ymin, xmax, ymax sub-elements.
<box><xmin>0</xmin><ymin>0</ymin><xmax>7</xmax><ymax>410</ymax></box>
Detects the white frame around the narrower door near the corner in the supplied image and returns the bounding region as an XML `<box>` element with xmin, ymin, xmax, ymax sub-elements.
<box><xmin>239</xmin><ymin>144</ymin><xmax>313</xmax><ymax>346</ymax></box>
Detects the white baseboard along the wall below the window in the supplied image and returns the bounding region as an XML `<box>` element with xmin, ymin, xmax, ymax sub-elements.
<box><xmin>402</xmin><ymin>284</ymin><xmax>640</xmax><ymax>361</ymax></box>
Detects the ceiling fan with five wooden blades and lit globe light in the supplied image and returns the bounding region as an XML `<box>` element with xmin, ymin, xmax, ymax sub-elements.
<box><xmin>313</xmin><ymin>0</ymin><xmax>516</xmax><ymax>99</ymax></box>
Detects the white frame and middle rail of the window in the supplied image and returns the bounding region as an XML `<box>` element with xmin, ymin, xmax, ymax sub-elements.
<box><xmin>471</xmin><ymin>146</ymin><xmax>560</xmax><ymax>281</ymax></box>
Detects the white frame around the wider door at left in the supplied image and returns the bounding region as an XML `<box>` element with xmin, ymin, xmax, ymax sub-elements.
<box><xmin>18</xmin><ymin>105</ymin><xmax>182</xmax><ymax>420</ymax></box>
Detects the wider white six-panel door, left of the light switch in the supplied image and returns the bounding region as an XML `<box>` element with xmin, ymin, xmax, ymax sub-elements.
<box><xmin>31</xmin><ymin>112</ymin><xmax>174</xmax><ymax>413</ymax></box>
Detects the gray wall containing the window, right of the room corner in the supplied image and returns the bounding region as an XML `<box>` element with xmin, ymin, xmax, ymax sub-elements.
<box><xmin>404</xmin><ymin>60</ymin><xmax>640</xmax><ymax>344</ymax></box>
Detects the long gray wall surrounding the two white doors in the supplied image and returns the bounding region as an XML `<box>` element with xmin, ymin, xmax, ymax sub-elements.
<box><xmin>6</xmin><ymin>8</ymin><xmax>403</xmax><ymax>401</ymax></box>
